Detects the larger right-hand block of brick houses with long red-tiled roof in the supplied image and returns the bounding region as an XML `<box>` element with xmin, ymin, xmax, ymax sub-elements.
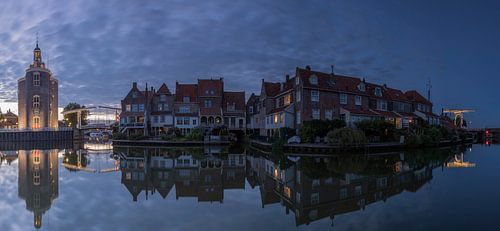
<box><xmin>246</xmin><ymin>66</ymin><xmax>440</xmax><ymax>136</ymax></box>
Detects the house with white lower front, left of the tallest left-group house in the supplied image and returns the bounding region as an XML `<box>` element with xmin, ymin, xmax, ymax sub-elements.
<box><xmin>174</xmin><ymin>82</ymin><xmax>200</xmax><ymax>135</ymax></box>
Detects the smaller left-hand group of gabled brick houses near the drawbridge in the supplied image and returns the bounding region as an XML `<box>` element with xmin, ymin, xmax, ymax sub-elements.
<box><xmin>120</xmin><ymin>78</ymin><xmax>246</xmax><ymax>135</ymax></box>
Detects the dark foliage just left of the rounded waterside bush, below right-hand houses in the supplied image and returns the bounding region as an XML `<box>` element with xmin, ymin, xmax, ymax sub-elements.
<box><xmin>300</xmin><ymin>119</ymin><xmax>346</xmax><ymax>143</ymax></box>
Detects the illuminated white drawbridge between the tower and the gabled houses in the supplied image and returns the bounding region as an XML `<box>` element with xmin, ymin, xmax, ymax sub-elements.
<box><xmin>62</xmin><ymin>105</ymin><xmax>122</xmax><ymax>130</ymax></box>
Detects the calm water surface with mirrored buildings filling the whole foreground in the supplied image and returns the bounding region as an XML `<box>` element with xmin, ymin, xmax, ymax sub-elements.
<box><xmin>0</xmin><ymin>144</ymin><xmax>500</xmax><ymax>230</ymax></box>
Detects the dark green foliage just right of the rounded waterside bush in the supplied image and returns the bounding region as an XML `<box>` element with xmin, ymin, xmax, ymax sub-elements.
<box><xmin>356</xmin><ymin>119</ymin><xmax>396</xmax><ymax>142</ymax></box>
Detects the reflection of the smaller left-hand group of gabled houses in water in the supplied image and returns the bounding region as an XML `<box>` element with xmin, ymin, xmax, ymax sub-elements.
<box><xmin>115</xmin><ymin>148</ymin><xmax>246</xmax><ymax>203</ymax></box>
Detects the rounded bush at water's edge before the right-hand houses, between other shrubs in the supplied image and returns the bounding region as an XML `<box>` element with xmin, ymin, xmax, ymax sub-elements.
<box><xmin>327</xmin><ymin>128</ymin><xmax>367</xmax><ymax>146</ymax></box>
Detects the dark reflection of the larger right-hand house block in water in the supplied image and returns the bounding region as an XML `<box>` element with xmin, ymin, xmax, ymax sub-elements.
<box><xmin>246</xmin><ymin>148</ymin><xmax>454</xmax><ymax>226</ymax></box>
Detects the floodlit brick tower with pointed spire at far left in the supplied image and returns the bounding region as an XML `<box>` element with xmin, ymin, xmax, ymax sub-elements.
<box><xmin>18</xmin><ymin>41</ymin><xmax>59</xmax><ymax>129</ymax></box>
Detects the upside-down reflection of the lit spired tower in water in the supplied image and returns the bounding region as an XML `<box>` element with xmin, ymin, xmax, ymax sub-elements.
<box><xmin>18</xmin><ymin>150</ymin><xmax>59</xmax><ymax>229</ymax></box>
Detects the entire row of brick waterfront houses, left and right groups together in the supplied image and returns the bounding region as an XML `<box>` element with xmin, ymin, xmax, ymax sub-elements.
<box><xmin>120</xmin><ymin>66</ymin><xmax>440</xmax><ymax>136</ymax></box>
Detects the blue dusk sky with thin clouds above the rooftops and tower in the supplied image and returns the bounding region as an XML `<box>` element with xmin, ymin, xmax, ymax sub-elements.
<box><xmin>0</xmin><ymin>0</ymin><xmax>500</xmax><ymax>127</ymax></box>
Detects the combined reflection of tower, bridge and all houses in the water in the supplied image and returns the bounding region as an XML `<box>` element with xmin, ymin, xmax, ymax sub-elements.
<box><xmin>0</xmin><ymin>144</ymin><xmax>469</xmax><ymax>228</ymax></box>
